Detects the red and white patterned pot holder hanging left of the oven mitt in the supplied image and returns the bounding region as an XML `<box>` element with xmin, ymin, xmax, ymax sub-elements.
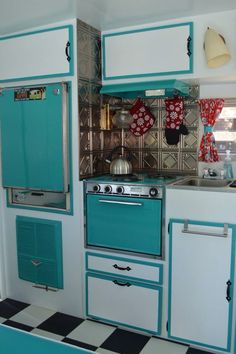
<box><xmin>130</xmin><ymin>98</ymin><xmax>155</xmax><ymax>136</ymax></box>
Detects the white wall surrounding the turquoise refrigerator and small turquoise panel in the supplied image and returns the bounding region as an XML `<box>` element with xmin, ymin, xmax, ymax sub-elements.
<box><xmin>0</xmin><ymin>20</ymin><xmax>84</xmax><ymax>316</ymax></box>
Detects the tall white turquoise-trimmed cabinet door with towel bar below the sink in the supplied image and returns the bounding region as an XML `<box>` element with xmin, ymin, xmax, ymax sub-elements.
<box><xmin>169</xmin><ymin>220</ymin><xmax>233</xmax><ymax>350</ymax></box>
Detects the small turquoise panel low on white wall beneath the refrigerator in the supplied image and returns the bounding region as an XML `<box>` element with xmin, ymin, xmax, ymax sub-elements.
<box><xmin>16</xmin><ymin>216</ymin><xmax>63</xmax><ymax>288</ymax></box>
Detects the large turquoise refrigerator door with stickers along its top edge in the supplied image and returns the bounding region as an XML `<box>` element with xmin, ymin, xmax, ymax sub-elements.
<box><xmin>0</xmin><ymin>84</ymin><xmax>64</xmax><ymax>191</ymax></box>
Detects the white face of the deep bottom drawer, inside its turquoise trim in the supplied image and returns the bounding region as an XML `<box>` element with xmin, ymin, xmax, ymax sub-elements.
<box><xmin>87</xmin><ymin>275</ymin><xmax>160</xmax><ymax>333</ymax></box>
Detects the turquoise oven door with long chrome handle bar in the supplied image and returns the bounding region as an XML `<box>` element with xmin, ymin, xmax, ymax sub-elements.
<box><xmin>86</xmin><ymin>194</ymin><xmax>162</xmax><ymax>256</ymax></box>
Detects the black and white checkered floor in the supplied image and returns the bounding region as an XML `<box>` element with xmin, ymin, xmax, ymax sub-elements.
<box><xmin>0</xmin><ymin>299</ymin><xmax>210</xmax><ymax>354</ymax></box>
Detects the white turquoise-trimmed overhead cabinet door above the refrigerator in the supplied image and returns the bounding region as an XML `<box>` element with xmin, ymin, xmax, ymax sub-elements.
<box><xmin>0</xmin><ymin>25</ymin><xmax>73</xmax><ymax>82</ymax></box>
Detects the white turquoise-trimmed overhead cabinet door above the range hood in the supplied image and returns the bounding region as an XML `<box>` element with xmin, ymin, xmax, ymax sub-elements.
<box><xmin>102</xmin><ymin>22</ymin><xmax>193</xmax><ymax>81</ymax></box>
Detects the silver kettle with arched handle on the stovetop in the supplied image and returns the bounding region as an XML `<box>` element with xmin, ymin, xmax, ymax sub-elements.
<box><xmin>106</xmin><ymin>145</ymin><xmax>132</xmax><ymax>175</ymax></box>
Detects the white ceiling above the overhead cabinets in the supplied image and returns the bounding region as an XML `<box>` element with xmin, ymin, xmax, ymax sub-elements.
<box><xmin>0</xmin><ymin>0</ymin><xmax>236</xmax><ymax>35</ymax></box>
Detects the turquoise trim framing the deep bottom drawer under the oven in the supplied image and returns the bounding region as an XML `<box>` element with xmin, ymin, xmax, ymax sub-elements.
<box><xmin>86</xmin><ymin>272</ymin><xmax>163</xmax><ymax>335</ymax></box>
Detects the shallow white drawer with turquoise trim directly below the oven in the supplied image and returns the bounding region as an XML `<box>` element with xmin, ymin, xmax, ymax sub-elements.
<box><xmin>87</xmin><ymin>255</ymin><xmax>162</xmax><ymax>284</ymax></box>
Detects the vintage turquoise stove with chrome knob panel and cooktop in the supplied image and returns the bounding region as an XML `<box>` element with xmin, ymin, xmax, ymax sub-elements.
<box><xmin>84</xmin><ymin>175</ymin><xmax>172</xmax><ymax>258</ymax></box>
